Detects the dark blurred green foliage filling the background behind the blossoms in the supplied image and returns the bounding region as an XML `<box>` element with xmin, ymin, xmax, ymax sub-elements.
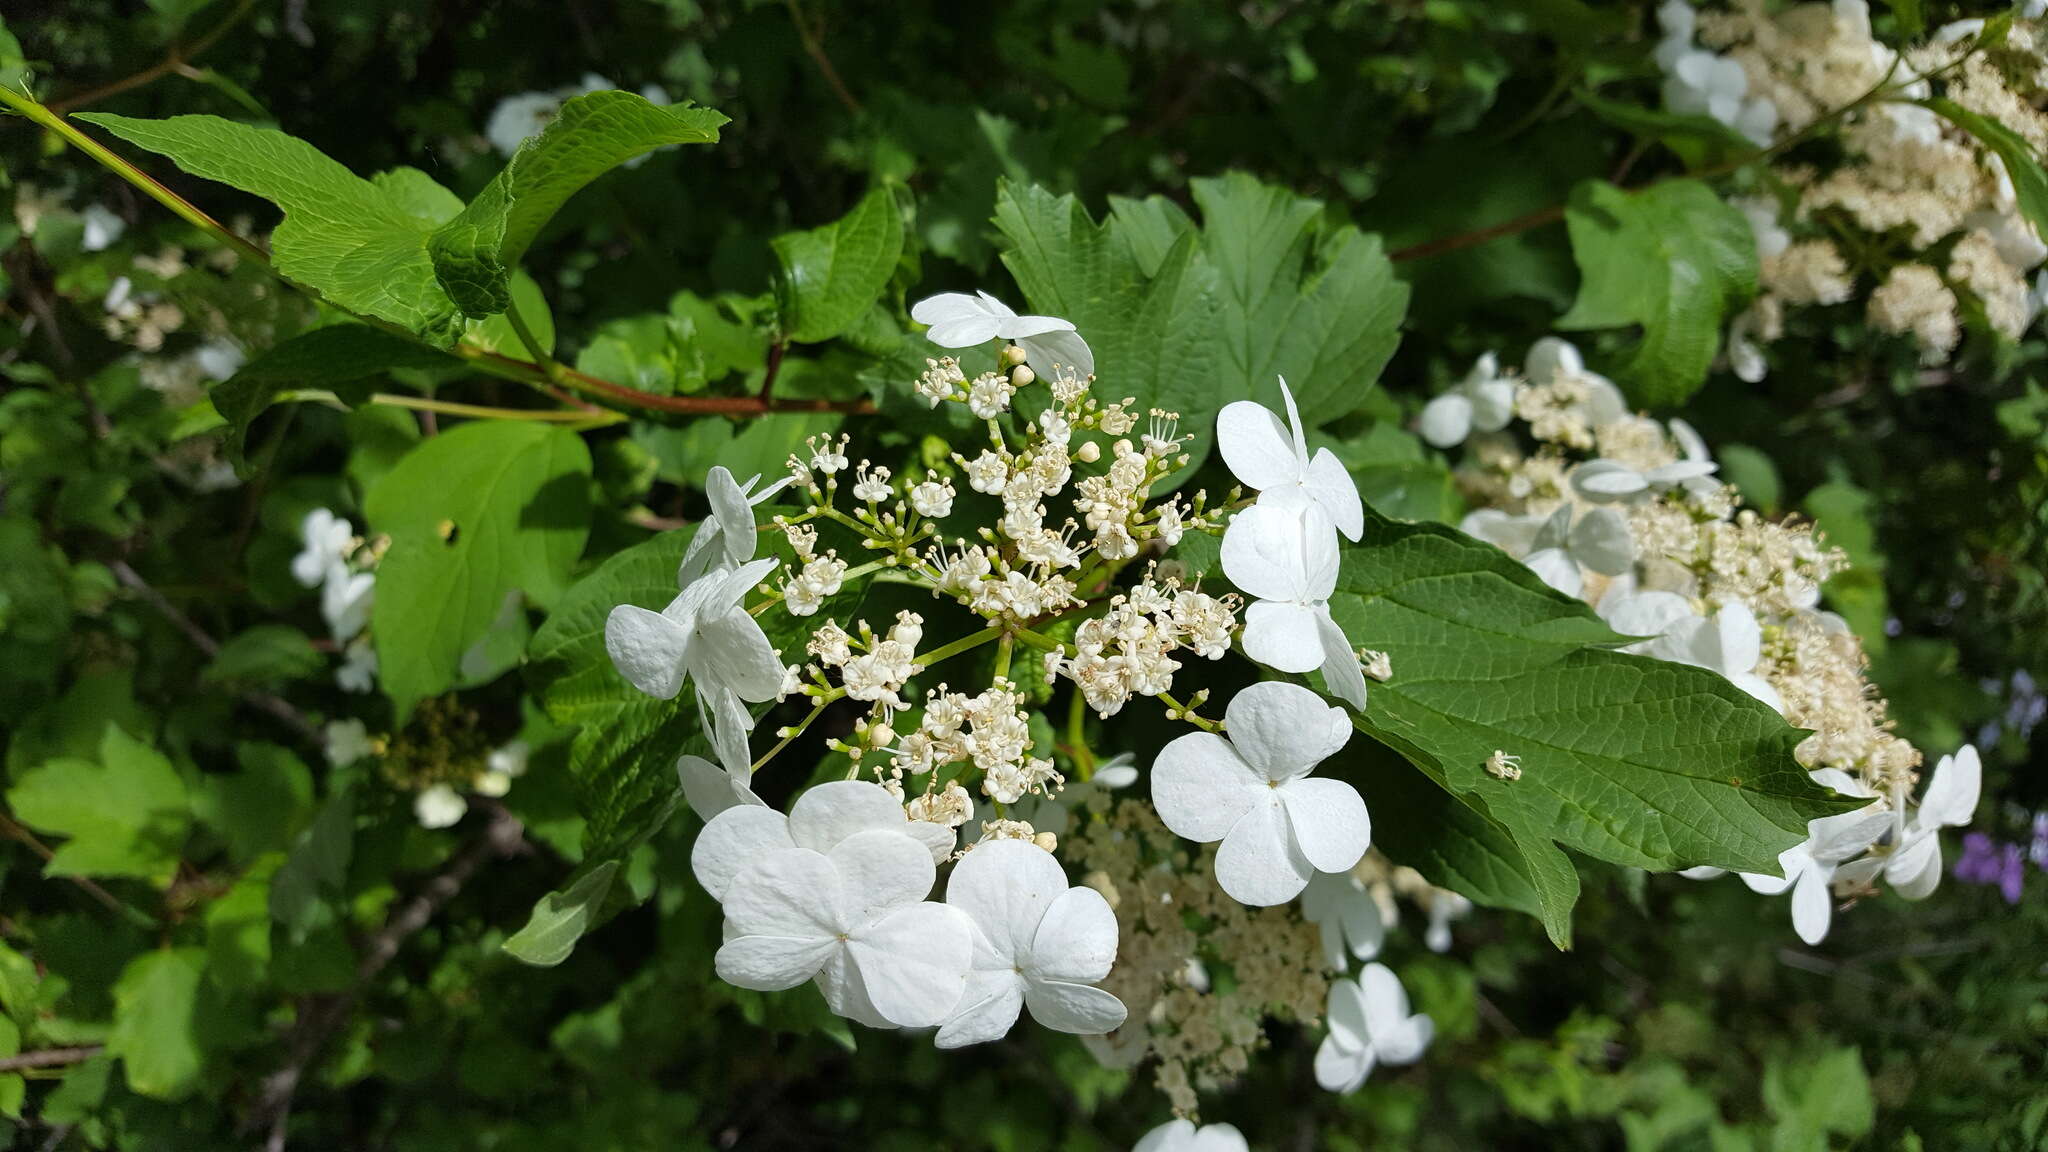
<box><xmin>0</xmin><ymin>0</ymin><xmax>2048</xmax><ymax>1152</ymax></box>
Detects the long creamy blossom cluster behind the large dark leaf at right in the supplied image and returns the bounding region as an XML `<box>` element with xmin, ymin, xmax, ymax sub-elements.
<box><xmin>1423</xmin><ymin>336</ymin><xmax>1980</xmax><ymax>943</ymax></box>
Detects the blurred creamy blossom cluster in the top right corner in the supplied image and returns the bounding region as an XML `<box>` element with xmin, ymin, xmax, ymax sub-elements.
<box><xmin>1687</xmin><ymin>0</ymin><xmax>2048</xmax><ymax>373</ymax></box>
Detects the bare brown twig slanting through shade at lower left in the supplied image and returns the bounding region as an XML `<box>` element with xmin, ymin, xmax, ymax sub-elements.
<box><xmin>248</xmin><ymin>799</ymin><xmax>526</xmax><ymax>1152</ymax></box>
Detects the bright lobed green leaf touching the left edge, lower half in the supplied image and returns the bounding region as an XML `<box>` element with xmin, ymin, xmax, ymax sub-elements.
<box><xmin>6</xmin><ymin>724</ymin><xmax>193</xmax><ymax>886</ymax></box>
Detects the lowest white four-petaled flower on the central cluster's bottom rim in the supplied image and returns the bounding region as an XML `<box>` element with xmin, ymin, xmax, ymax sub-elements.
<box><xmin>938</xmin><ymin>840</ymin><xmax>1124</xmax><ymax>1047</ymax></box>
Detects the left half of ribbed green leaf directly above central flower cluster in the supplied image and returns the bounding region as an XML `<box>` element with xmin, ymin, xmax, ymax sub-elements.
<box><xmin>995</xmin><ymin>182</ymin><xmax>1241</xmax><ymax>476</ymax></box>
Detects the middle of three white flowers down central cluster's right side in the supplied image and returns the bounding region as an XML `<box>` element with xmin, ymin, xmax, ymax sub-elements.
<box><xmin>1223</xmin><ymin>504</ymin><xmax>1366</xmax><ymax>711</ymax></box>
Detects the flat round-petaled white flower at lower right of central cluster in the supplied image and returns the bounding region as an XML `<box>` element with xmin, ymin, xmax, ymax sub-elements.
<box><xmin>1151</xmin><ymin>681</ymin><xmax>1372</xmax><ymax>906</ymax></box>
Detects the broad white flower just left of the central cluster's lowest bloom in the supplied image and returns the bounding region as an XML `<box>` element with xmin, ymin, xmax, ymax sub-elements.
<box><xmin>717</xmin><ymin>824</ymin><xmax>973</xmax><ymax>1027</ymax></box>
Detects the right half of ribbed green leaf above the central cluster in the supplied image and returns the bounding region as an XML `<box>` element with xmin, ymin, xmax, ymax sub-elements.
<box><xmin>1194</xmin><ymin>172</ymin><xmax>1407</xmax><ymax>426</ymax></box>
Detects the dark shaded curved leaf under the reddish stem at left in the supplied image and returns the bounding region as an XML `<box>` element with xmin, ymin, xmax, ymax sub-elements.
<box><xmin>209</xmin><ymin>324</ymin><xmax>453</xmax><ymax>461</ymax></box>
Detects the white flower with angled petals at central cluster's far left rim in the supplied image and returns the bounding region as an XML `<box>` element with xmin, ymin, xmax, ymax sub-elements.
<box><xmin>604</xmin><ymin>558</ymin><xmax>782</xmax><ymax>765</ymax></box>
